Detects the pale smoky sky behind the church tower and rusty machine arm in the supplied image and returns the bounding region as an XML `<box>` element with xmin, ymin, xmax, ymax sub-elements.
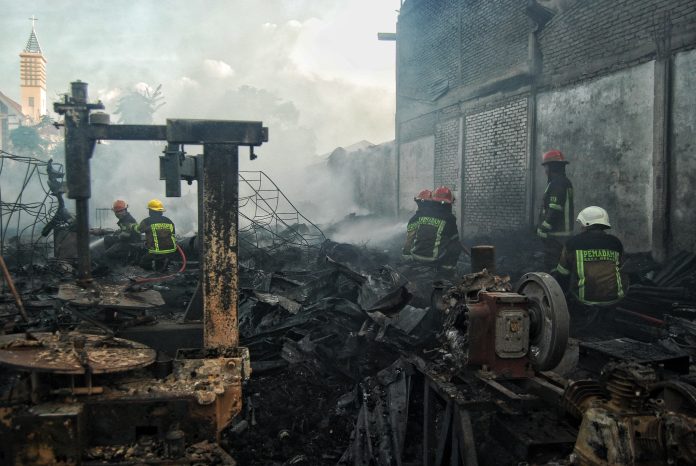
<box><xmin>0</xmin><ymin>0</ymin><xmax>399</xmax><ymax>237</ymax></box>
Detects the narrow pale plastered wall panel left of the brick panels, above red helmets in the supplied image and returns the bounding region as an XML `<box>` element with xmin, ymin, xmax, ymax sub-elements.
<box><xmin>399</xmin><ymin>136</ymin><xmax>435</xmax><ymax>211</ymax></box>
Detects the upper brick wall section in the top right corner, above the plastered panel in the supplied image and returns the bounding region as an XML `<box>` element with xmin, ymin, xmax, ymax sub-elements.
<box><xmin>539</xmin><ymin>0</ymin><xmax>696</xmax><ymax>78</ymax></box>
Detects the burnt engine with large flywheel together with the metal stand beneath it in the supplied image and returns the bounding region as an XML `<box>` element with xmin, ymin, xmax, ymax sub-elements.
<box><xmin>410</xmin><ymin>272</ymin><xmax>576</xmax><ymax>466</ymax></box>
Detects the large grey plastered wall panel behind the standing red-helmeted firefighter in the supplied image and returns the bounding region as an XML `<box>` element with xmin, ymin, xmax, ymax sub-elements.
<box><xmin>535</xmin><ymin>62</ymin><xmax>654</xmax><ymax>251</ymax></box>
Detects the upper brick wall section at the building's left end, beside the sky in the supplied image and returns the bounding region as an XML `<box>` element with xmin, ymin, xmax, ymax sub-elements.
<box><xmin>399</xmin><ymin>0</ymin><xmax>529</xmax><ymax>101</ymax></box>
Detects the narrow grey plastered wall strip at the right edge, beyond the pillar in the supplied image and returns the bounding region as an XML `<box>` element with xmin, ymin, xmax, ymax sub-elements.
<box><xmin>670</xmin><ymin>50</ymin><xmax>696</xmax><ymax>251</ymax></box>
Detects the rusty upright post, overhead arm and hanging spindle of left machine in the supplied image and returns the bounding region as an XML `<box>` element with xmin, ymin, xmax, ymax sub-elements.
<box><xmin>54</xmin><ymin>81</ymin><xmax>268</xmax><ymax>348</ymax></box>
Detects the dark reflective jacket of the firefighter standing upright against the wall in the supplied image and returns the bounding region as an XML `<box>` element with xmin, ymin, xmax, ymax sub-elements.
<box><xmin>537</xmin><ymin>173</ymin><xmax>575</xmax><ymax>239</ymax></box>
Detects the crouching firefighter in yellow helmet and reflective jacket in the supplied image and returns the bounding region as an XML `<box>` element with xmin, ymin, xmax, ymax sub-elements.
<box><xmin>133</xmin><ymin>199</ymin><xmax>176</xmax><ymax>270</ymax></box>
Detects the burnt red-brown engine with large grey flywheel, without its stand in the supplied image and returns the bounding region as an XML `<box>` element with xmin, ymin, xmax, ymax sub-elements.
<box><xmin>441</xmin><ymin>271</ymin><xmax>569</xmax><ymax>379</ymax></box>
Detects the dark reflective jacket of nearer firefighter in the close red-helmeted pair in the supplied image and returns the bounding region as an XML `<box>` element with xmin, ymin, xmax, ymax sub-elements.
<box><xmin>402</xmin><ymin>201</ymin><xmax>461</xmax><ymax>268</ymax></box>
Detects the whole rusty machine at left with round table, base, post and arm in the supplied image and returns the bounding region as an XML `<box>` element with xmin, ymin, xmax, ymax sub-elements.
<box><xmin>0</xmin><ymin>81</ymin><xmax>268</xmax><ymax>464</ymax></box>
